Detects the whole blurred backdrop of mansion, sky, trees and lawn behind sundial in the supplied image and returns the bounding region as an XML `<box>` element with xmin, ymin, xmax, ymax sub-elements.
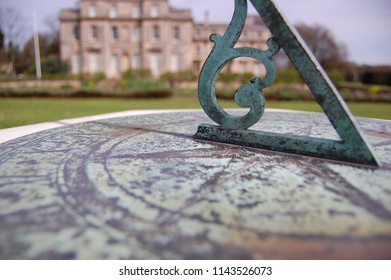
<box><xmin>0</xmin><ymin>0</ymin><xmax>391</xmax><ymax>129</ymax></box>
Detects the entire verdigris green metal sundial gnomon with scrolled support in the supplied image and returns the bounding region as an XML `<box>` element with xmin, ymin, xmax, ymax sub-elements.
<box><xmin>194</xmin><ymin>0</ymin><xmax>378</xmax><ymax>166</ymax></box>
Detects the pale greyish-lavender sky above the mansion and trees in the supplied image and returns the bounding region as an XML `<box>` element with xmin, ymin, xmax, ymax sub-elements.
<box><xmin>0</xmin><ymin>0</ymin><xmax>391</xmax><ymax>65</ymax></box>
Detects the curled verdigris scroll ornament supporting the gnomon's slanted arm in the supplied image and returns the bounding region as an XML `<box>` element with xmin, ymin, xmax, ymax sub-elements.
<box><xmin>198</xmin><ymin>0</ymin><xmax>280</xmax><ymax>129</ymax></box>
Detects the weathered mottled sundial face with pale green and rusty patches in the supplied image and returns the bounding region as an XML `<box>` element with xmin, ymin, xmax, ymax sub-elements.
<box><xmin>0</xmin><ymin>111</ymin><xmax>391</xmax><ymax>259</ymax></box>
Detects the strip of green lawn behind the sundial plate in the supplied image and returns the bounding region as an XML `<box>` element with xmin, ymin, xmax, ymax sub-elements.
<box><xmin>0</xmin><ymin>97</ymin><xmax>391</xmax><ymax>128</ymax></box>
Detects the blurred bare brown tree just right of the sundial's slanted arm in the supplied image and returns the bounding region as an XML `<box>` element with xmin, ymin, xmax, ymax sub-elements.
<box><xmin>296</xmin><ymin>24</ymin><xmax>348</xmax><ymax>68</ymax></box>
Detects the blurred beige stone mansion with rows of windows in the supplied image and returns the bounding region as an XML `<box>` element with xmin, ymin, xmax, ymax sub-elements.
<box><xmin>60</xmin><ymin>0</ymin><xmax>270</xmax><ymax>78</ymax></box>
